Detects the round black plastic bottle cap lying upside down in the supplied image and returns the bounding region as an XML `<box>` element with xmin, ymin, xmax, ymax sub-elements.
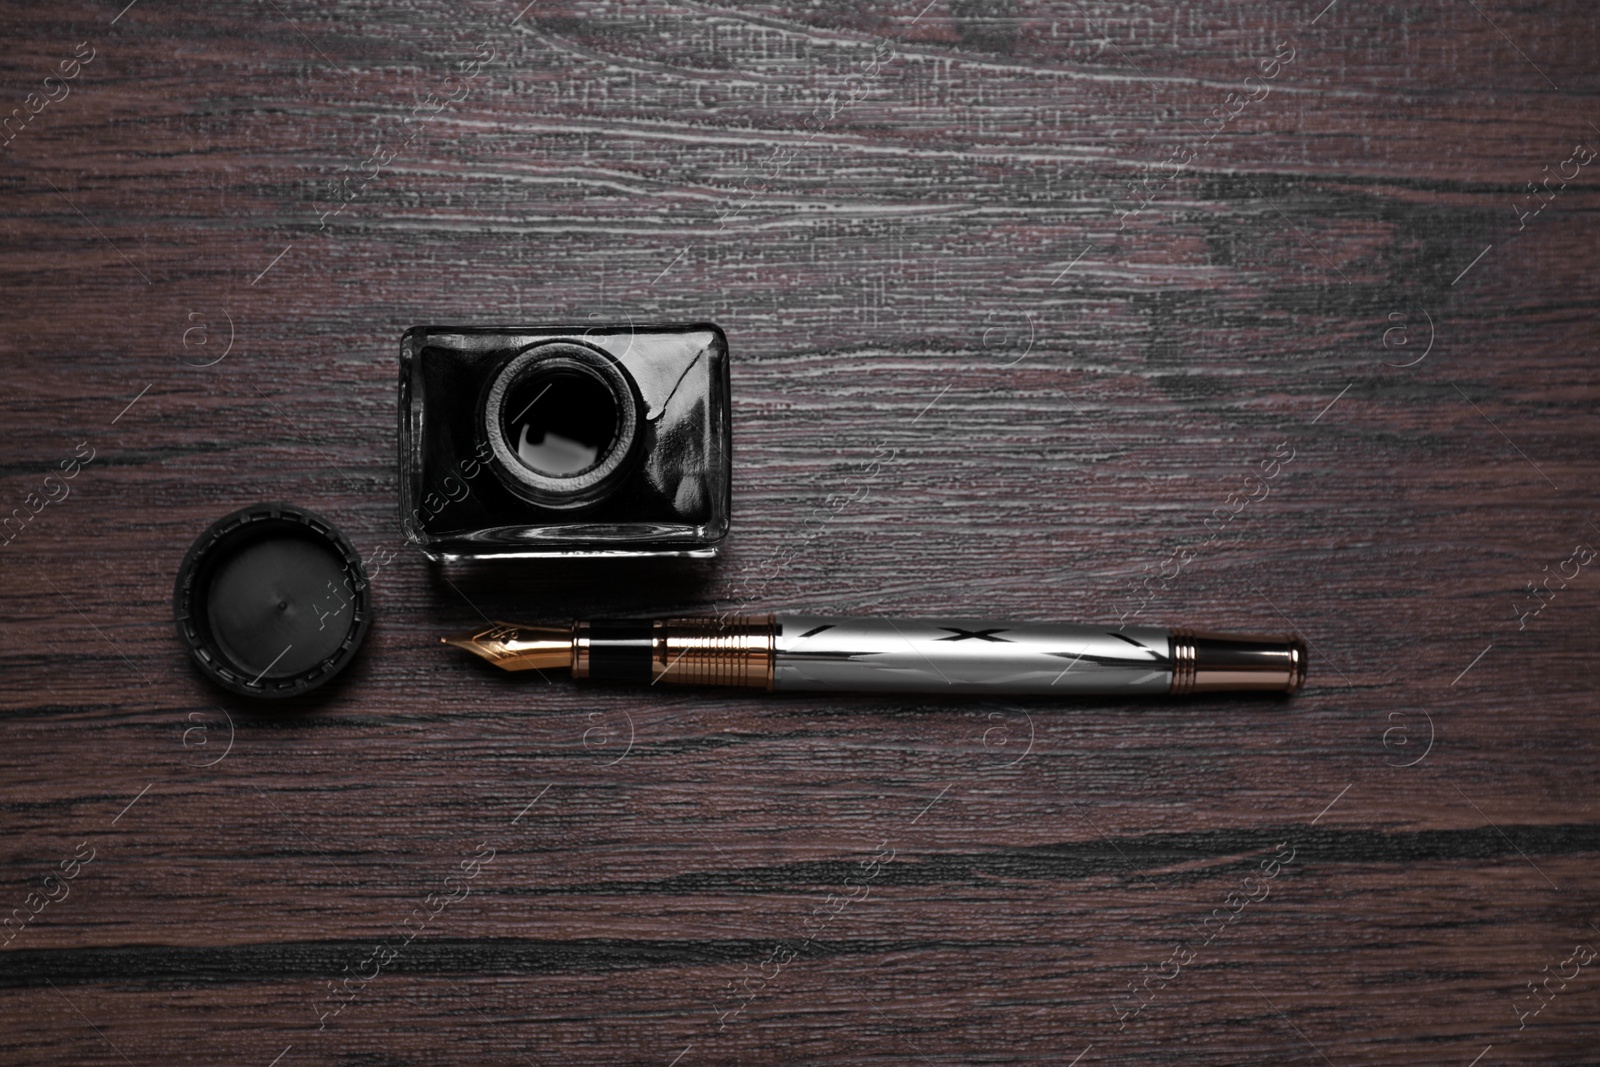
<box><xmin>173</xmin><ymin>504</ymin><xmax>373</xmax><ymax>697</ymax></box>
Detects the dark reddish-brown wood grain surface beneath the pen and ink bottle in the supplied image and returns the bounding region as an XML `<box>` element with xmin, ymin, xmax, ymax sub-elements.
<box><xmin>0</xmin><ymin>0</ymin><xmax>1600</xmax><ymax>1067</ymax></box>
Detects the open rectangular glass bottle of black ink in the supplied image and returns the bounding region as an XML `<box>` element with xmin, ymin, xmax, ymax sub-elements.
<box><xmin>400</xmin><ymin>323</ymin><xmax>731</xmax><ymax>561</ymax></box>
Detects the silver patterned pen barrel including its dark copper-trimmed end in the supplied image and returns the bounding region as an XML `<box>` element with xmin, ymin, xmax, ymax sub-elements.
<box><xmin>773</xmin><ymin>614</ymin><xmax>1306</xmax><ymax>696</ymax></box>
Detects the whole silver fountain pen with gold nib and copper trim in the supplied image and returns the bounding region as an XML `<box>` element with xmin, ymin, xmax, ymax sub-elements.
<box><xmin>440</xmin><ymin>614</ymin><xmax>1306</xmax><ymax>696</ymax></box>
